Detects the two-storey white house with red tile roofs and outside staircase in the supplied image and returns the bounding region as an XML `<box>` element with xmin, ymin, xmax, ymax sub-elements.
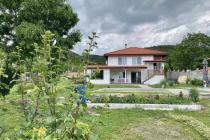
<box><xmin>85</xmin><ymin>47</ymin><xmax>167</xmax><ymax>84</ymax></box>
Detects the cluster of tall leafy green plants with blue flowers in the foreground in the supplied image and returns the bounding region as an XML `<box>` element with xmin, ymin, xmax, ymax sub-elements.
<box><xmin>11</xmin><ymin>31</ymin><xmax>90</xmax><ymax>139</ymax></box>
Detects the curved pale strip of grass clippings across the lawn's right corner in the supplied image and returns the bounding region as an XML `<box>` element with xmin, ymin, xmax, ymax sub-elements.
<box><xmin>169</xmin><ymin>114</ymin><xmax>210</xmax><ymax>139</ymax></box>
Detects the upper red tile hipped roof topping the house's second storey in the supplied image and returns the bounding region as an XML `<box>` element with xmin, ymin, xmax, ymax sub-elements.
<box><xmin>104</xmin><ymin>47</ymin><xmax>168</xmax><ymax>56</ymax></box>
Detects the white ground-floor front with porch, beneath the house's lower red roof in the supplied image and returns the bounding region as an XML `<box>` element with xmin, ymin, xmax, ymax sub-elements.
<box><xmin>87</xmin><ymin>66</ymin><xmax>164</xmax><ymax>84</ymax></box>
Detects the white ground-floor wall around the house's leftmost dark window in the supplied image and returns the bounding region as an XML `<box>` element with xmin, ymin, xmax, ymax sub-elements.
<box><xmin>87</xmin><ymin>69</ymin><xmax>110</xmax><ymax>84</ymax></box>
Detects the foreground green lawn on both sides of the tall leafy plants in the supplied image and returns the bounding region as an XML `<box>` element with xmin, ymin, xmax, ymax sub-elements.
<box><xmin>0</xmin><ymin>96</ymin><xmax>210</xmax><ymax>140</ymax></box>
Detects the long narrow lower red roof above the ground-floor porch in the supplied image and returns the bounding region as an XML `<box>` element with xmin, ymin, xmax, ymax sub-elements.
<box><xmin>86</xmin><ymin>65</ymin><xmax>147</xmax><ymax>69</ymax></box>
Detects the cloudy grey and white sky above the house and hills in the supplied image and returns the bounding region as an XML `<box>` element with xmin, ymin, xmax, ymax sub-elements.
<box><xmin>69</xmin><ymin>0</ymin><xmax>210</xmax><ymax>55</ymax></box>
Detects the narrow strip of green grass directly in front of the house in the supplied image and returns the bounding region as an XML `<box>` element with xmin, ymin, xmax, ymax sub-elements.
<box><xmin>93</xmin><ymin>84</ymin><xmax>140</xmax><ymax>90</ymax></box>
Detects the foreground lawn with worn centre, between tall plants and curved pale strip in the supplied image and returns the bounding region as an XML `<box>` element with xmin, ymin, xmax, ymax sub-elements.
<box><xmin>84</xmin><ymin>109</ymin><xmax>207</xmax><ymax>140</ymax></box>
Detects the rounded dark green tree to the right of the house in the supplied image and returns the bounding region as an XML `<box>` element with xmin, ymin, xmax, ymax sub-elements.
<box><xmin>167</xmin><ymin>33</ymin><xmax>210</xmax><ymax>70</ymax></box>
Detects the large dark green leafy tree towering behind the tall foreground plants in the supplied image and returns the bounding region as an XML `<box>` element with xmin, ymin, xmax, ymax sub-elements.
<box><xmin>0</xmin><ymin>0</ymin><xmax>81</xmax><ymax>96</ymax></box>
